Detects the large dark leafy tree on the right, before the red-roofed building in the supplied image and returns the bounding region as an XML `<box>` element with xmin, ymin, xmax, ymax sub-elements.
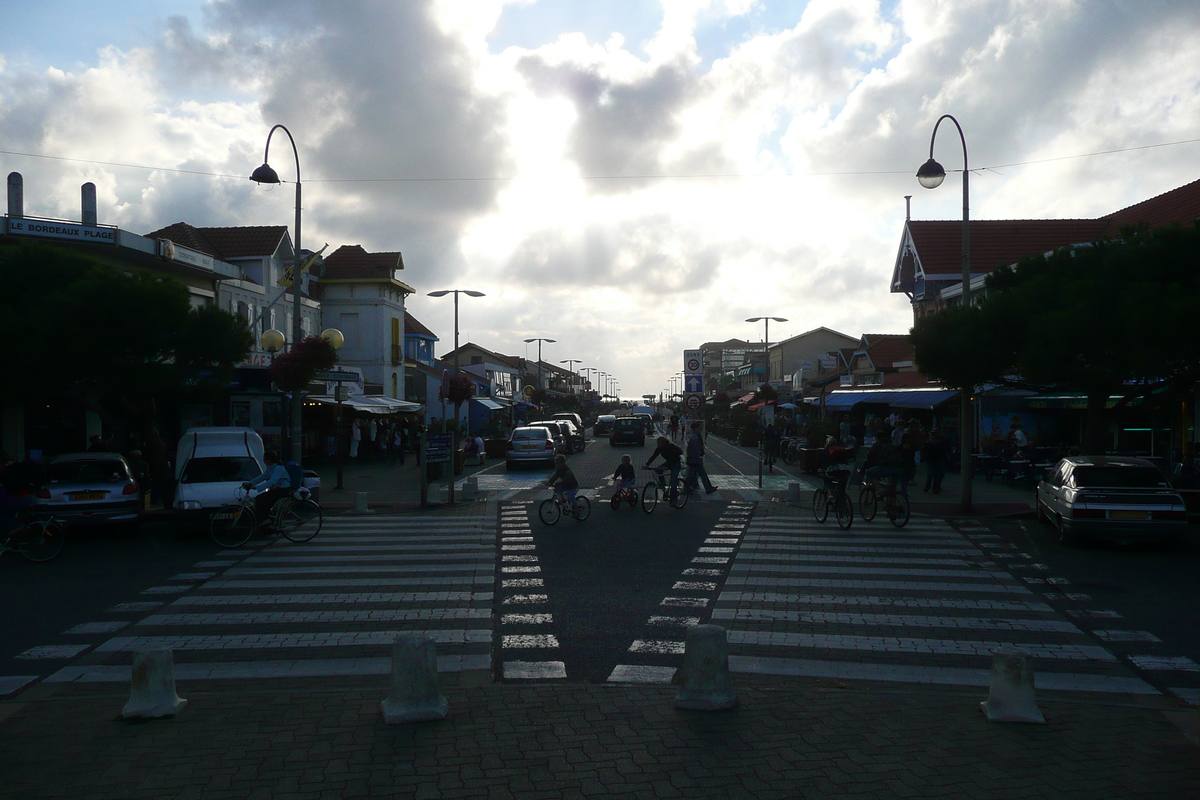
<box><xmin>912</xmin><ymin>225</ymin><xmax>1200</xmax><ymax>452</ymax></box>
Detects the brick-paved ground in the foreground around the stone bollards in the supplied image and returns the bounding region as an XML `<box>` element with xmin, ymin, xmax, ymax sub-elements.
<box><xmin>0</xmin><ymin>678</ymin><xmax>1200</xmax><ymax>800</ymax></box>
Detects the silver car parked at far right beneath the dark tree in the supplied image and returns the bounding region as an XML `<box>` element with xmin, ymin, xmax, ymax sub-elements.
<box><xmin>1037</xmin><ymin>456</ymin><xmax>1188</xmax><ymax>543</ymax></box>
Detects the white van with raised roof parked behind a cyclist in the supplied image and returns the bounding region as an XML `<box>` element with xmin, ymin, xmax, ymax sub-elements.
<box><xmin>175</xmin><ymin>428</ymin><xmax>264</xmax><ymax>513</ymax></box>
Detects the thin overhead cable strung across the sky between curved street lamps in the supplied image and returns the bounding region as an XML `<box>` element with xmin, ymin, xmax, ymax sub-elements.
<box><xmin>0</xmin><ymin>139</ymin><xmax>1200</xmax><ymax>184</ymax></box>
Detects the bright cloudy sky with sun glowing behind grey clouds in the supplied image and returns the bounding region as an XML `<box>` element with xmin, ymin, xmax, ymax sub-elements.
<box><xmin>0</xmin><ymin>0</ymin><xmax>1200</xmax><ymax>397</ymax></box>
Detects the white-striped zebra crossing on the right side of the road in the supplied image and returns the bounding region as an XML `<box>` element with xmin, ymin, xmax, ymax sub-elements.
<box><xmin>712</xmin><ymin>513</ymin><xmax>1158</xmax><ymax>694</ymax></box>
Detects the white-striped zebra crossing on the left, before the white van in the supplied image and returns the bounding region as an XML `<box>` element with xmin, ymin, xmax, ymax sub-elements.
<box><xmin>47</xmin><ymin>516</ymin><xmax>497</xmax><ymax>682</ymax></box>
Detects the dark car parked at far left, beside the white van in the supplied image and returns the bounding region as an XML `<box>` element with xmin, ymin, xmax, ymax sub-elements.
<box><xmin>35</xmin><ymin>452</ymin><xmax>143</xmax><ymax>525</ymax></box>
